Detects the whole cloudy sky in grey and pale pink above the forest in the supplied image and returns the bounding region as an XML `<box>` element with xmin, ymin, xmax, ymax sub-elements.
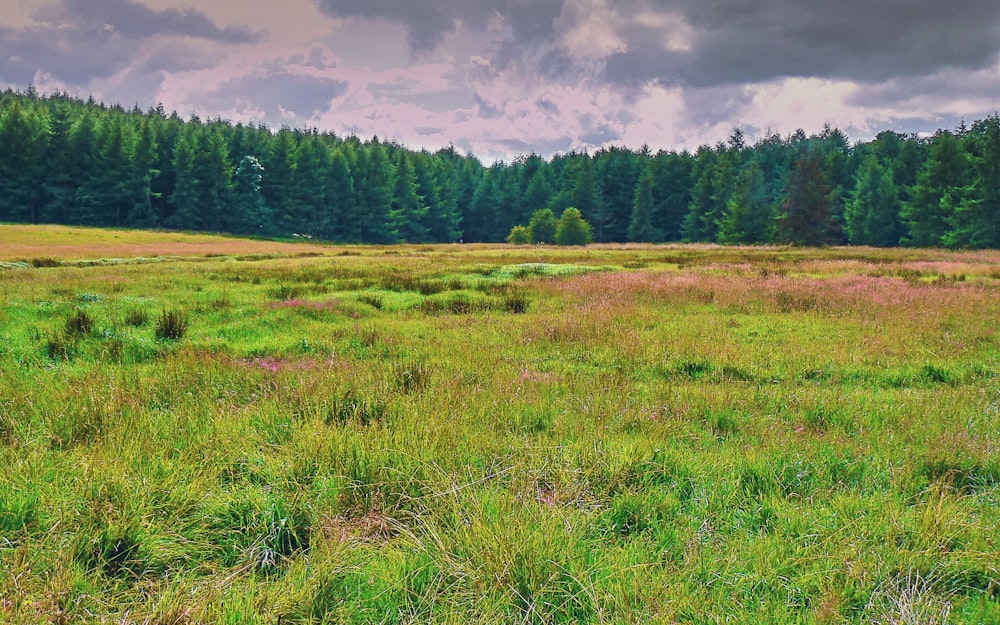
<box><xmin>0</xmin><ymin>0</ymin><xmax>1000</xmax><ymax>160</ymax></box>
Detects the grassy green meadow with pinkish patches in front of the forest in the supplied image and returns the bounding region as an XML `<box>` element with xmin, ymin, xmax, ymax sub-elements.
<box><xmin>0</xmin><ymin>226</ymin><xmax>1000</xmax><ymax>625</ymax></box>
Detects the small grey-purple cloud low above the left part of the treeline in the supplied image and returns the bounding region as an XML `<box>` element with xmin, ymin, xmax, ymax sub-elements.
<box><xmin>197</xmin><ymin>72</ymin><xmax>348</xmax><ymax>118</ymax></box>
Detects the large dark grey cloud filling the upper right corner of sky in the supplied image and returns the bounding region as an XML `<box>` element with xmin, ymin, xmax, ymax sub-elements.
<box><xmin>606</xmin><ymin>0</ymin><xmax>1000</xmax><ymax>86</ymax></box>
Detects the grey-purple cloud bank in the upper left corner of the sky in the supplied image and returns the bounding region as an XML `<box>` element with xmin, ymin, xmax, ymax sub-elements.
<box><xmin>0</xmin><ymin>0</ymin><xmax>260</xmax><ymax>86</ymax></box>
